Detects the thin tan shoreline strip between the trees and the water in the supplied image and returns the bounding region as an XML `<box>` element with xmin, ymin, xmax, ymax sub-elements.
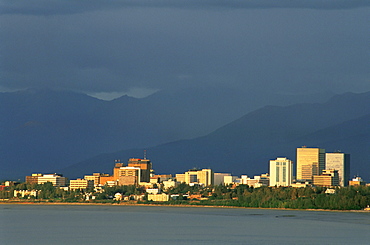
<box><xmin>0</xmin><ymin>201</ymin><xmax>370</xmax><ymax>213</ymax></box>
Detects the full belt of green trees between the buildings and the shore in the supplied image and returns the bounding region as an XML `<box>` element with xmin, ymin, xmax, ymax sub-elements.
<box><xmin>0</xmin><ymin>183</ymin><xmax>370</xmax><ymax>210</ymax></box>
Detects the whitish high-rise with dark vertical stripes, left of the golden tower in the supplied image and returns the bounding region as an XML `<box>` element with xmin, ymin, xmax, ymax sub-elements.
<box><xmin>270</xmin><ymin>157</ymin><xmax>293</xmax><ymax>186</ymax></box>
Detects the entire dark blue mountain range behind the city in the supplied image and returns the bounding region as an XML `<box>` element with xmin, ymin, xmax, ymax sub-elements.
<box><xmin>0</xmin><ymin>88</ymin><xmax>370</xmax><ymax>181</ymax></box>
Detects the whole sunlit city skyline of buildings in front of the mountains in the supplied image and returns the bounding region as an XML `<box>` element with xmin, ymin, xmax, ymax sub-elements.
<box><xmin>18</xmin><ymin>146</ymin><xmax>358</xmax><ymax>187</ymax></box>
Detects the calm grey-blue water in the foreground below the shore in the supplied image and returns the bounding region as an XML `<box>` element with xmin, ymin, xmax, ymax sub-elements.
<box><xmin>0</xmin><ymin>205</ymin><xmax>370</xmax><ymax>245</ymax></box>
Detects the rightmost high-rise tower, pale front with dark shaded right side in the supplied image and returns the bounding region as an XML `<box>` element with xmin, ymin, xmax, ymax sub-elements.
<box><xmin>325</xmin><ymin>152</ymin><xmax>350</xmax><ymax>186</ymax></box>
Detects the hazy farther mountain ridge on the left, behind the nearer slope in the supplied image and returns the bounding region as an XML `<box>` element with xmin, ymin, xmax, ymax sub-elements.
<box><xmin>0</xmin><ymin>88</ymin><xmax>331</xmax><ymax>179</ymax></box>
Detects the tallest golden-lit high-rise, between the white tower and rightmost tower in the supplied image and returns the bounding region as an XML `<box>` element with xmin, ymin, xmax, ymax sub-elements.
<box><xmin>296</xmin><ymin>146</ymin><xmax>325</xmax><ymax>181</ymax></box>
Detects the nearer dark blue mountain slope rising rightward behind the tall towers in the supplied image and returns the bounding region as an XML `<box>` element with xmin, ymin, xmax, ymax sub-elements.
<box><xmin>61</xmin><ymin>92</ymin><xmax>370</xmax><ymax>180</ymax></box>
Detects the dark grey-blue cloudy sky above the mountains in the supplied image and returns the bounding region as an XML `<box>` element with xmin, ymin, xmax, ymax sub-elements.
<box><xmin>0</xmin><ymin>0</ymin><xmax>370</xmax><ymax>99</ymax></box>
